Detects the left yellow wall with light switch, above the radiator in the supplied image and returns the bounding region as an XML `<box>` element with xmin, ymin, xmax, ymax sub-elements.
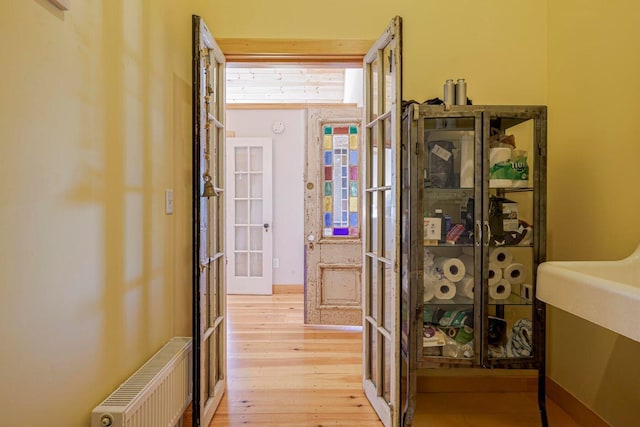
<box><xmin>0</xmin><ymin>0</ymin><xmax>191</xmax><ymax>427</ymax></box>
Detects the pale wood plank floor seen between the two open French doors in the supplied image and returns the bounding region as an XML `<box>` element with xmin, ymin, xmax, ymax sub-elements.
<box><xmin>210</xmin><ymin>294</ymin><xmax>382</xmax><ymax>427</ymax></box>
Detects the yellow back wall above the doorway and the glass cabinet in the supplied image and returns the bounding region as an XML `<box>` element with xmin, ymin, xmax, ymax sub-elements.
<box><xmin>195</xmin><ymin>0</ymin><xmax>547</xmax><ymax>104</ymax></box>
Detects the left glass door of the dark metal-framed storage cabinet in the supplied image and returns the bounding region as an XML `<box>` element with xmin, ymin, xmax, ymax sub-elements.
<box><xmin>417</xmin><ymin>112</ymin><xmax>482</xmax><ymax>366</ymax></box>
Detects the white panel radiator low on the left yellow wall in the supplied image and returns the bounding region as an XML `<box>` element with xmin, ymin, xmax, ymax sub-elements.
<box><xmin>91</xmin><ymin>337</ymin><xmax>193</xmax><ymax>427</ymax></box>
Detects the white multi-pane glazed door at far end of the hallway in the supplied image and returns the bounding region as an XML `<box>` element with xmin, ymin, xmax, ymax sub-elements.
<box><xmin>226</xmin><ymin>138</ymin><xmax>273</xmax><ymax>295</ymax></box>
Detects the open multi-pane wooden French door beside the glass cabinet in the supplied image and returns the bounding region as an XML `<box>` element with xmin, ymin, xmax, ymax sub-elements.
<box><xmin>362</xmin><ymin>17</ymin><xmax>402</xmax><ymax>427</ymax></box>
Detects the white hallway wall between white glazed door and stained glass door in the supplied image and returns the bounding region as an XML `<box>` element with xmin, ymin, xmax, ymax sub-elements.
<box><xmin>227</xmin><ymin>110</ymin><xmax>306</xmax><ymax>285</ymax></box>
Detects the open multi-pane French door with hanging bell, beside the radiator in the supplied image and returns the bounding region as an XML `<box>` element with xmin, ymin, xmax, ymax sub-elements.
<box><xmin>192</xmin><ymin>15</ymin><xmax>227</xmax><ymax>426</ymax></box>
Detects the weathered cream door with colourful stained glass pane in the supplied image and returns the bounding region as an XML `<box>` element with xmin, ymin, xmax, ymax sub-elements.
<box><xmin>304</xmin><ymin>108</ymin><xmax>362</xmax><ymax>325</ymax></box>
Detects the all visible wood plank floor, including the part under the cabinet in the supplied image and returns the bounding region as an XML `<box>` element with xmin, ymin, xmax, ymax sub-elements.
<box><xmin>185</xmin><ymin>294</ymin><xmax>578</xmax><ymax>427</ymax></box>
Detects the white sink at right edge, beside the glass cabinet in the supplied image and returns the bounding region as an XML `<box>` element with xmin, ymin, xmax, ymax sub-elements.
<box><xmin>536</xmin><ymin>246</ymin><xmax>640</xmax><ymax>342</ymax></box>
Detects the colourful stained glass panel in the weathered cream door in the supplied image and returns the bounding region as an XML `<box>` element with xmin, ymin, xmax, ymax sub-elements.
<box><xmin>322</xmin><ymin>125</ymin><xmax>360</xmax><ymax>237</ymax></box>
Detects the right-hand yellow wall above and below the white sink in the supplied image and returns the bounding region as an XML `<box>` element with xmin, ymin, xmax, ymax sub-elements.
<box><xmin>547</xmin><ymin>0</ymin><xmax>640</xmax><ymax>426</ymax></box>
